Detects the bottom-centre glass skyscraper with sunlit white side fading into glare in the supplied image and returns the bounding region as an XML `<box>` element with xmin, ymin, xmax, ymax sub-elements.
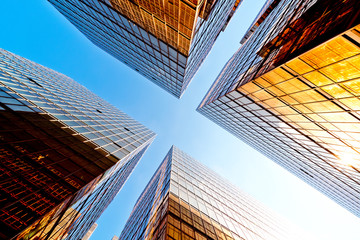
<box><xmin>120</xmin><ymin>146</ymin><xmax>311</xmax><ymax>240</ymax></box>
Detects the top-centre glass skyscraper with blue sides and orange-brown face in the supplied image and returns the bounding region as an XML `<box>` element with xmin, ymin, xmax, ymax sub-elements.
<box><xmin>45</xmin><ymin>0</ymin><xmax>241</xmax><ymax>98</ymax></box>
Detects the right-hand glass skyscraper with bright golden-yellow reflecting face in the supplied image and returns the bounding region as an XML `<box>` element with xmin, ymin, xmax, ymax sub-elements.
<box><xmin>198</xmin><ymin>0</ymin><xmax>360</xmax><ymax>217</ymax></box>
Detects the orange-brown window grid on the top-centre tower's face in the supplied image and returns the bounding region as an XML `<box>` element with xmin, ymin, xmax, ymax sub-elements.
<box><xmin>110</xmin><ymin>0</ymin><xmax>198</xmax><ymax>55</ymax></box>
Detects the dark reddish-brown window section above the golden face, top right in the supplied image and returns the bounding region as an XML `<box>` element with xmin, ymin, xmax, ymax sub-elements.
<box><xmin>248</xmin><ymin>0</ymin><xmax>360</xmax><ymax>84</ymax></box>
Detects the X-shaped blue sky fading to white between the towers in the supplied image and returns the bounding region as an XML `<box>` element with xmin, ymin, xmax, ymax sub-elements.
<box><xmin>0</xmin><ymin>0</ymin><xmax>360</xmax><ymax>240</ymax></box>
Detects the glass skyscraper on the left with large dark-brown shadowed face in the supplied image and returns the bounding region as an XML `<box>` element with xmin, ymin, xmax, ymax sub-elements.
<box><xmin>0</xmin><ymin>49</ymin><xmax>155</xmax><ymax>239</ymax></box>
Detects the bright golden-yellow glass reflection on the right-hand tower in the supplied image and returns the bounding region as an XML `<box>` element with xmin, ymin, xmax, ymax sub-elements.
<box><xmin>237</xmin><ymin>25</ymin><xmax>360</xmax><ymax>174</ymax></box>
